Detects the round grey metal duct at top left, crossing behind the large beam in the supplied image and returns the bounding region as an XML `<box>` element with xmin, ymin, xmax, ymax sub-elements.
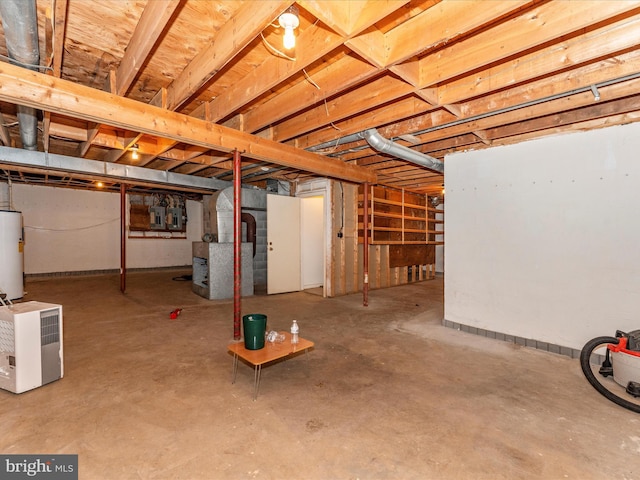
<box><xmin>0</xmin><ymin>0</ymin><xmax>40</xmax><ymax>150</ymax></box>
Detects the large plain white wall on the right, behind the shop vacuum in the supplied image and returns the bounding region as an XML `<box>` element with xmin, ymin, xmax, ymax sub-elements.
<box><xmin>444</xmin><ymin>123</ymin><xmax>640</xmax><ymax>356</ymax></box>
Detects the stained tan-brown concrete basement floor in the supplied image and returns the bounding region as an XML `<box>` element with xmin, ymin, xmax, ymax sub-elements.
<box><xmin>0</xmin><ymin>271</ymin><xmax>640</xmax><ymax>480</ymax></box>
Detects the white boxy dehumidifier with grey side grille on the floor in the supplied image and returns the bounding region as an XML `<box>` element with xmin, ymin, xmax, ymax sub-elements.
<box><xmin>0</xmin><ymin>302</ymin><xmax>64</xmax><ymax>393</ymax></box>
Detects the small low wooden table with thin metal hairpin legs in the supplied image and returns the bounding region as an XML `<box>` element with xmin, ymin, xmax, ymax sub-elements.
<box><xmin>228</xmin><ymin>332</ymin><xmax>314</xmax><ymax>400</ymax></box>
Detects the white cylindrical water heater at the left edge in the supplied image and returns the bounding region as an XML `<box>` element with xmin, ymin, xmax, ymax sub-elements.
<box><xmin>0</xmin><ymin>210</ymin><xmax>24</xmax><ymax>300</ymax></box>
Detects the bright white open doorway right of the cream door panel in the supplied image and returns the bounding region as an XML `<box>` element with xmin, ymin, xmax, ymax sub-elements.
<box><xmin>300</xmin><ymin>196</ymin><xmax>324</xmax><ymax>289</ymax></box>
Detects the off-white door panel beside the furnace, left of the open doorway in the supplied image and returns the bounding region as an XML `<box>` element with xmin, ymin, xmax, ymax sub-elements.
<box><xmin>267</xmin><ymin>195</ymin><xmax>302</xmax><ymax>294</ymax></box>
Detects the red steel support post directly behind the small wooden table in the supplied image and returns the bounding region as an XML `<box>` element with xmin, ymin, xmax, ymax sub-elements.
<box><xmin>233</xmin><ymin>148</ymin><xmax>242</xmax><ymax>340</ymax></box>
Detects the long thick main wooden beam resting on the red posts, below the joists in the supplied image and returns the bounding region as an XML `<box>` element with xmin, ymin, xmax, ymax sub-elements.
<box><xmin>0</xmin><ymin>63</ymin><xmax>376</xmax><ymax>183</ymax></box>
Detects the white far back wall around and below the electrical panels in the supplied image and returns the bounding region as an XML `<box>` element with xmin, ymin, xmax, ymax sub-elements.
<box><xmin>12</xmin><ymin>183</ymin><xmax>202</xmax><ymax>274</ymax></box>
